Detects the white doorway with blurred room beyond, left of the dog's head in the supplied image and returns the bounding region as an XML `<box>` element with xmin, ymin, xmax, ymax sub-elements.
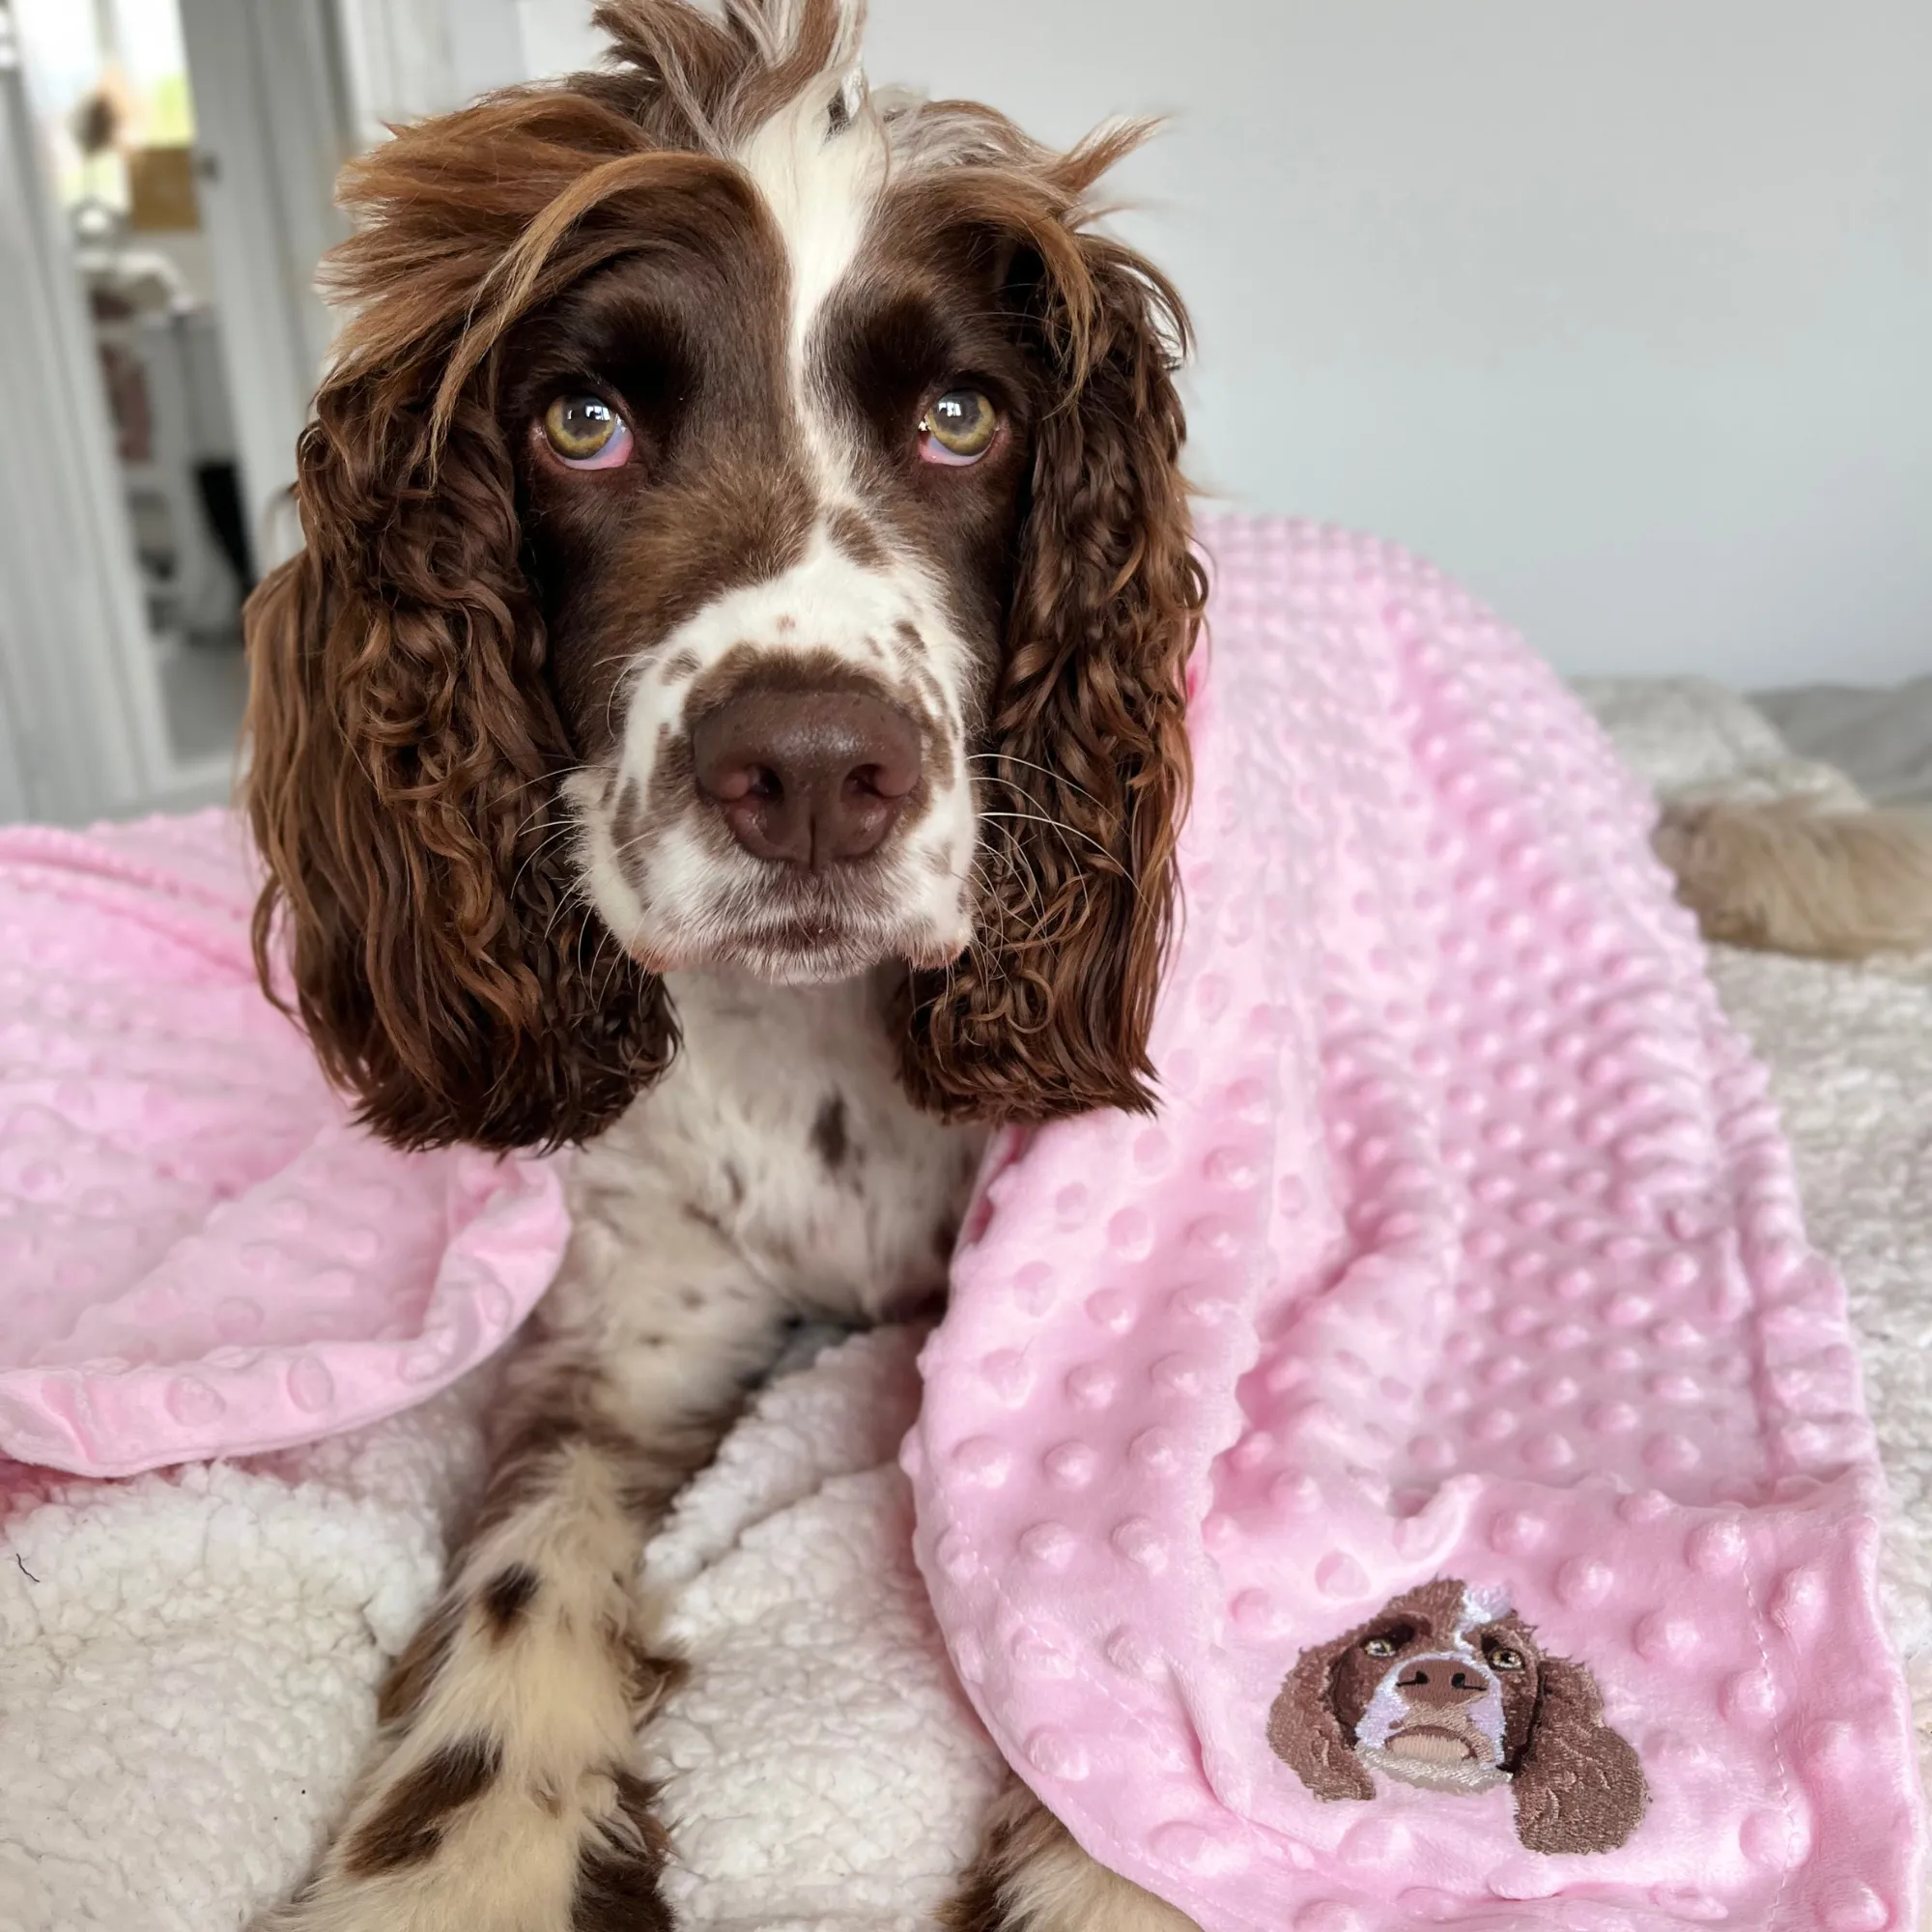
<box><xmin>0</xmin><ymin>0</ymin><xmax>355</xmax><ymax>823</ymax></box>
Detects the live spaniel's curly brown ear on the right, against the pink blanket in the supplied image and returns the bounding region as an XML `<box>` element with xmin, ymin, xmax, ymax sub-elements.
<box><xmin>906</xmin><ymin>166</ymin><xmax>1206</xmax><ymax>1121</ymax></box>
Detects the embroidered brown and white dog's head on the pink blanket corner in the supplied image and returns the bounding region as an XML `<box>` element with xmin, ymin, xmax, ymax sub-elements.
<box><xmin>1267</xmin><ymin>1578</ymin><xmax>1648</xmax><ymax>1853</ymax></box>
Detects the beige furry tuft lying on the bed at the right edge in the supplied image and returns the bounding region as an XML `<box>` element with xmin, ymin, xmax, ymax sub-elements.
<box><xmin>1654</xmin><ymin>798</ymin><xmax>1932</xmax><ymax>960</ymax></box>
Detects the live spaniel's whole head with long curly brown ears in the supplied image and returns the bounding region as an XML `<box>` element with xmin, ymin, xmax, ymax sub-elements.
<box><xmin>247</xmin><ymin>0</ymin><xmax>1204</xmax><ymax>1146</ymax></box>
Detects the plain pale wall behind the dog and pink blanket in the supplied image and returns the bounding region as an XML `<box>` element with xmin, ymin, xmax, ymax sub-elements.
<box><xmin>518</xmin><ymin>0</ymin><xmax>1932</xmax><ymax>686</ymax></box>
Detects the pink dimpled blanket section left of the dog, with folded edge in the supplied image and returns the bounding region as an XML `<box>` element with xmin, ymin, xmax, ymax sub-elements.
<box><xmin>0</xmin><ymin>811</ymin><xmax>568</xmax><ymax>1476</ymax></box>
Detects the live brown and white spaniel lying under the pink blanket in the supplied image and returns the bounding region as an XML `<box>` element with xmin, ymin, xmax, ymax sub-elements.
<box><xmin>247</xmin><ymin>0</ymin><xmax>1204</xmax><ymax>1932</ymax></box>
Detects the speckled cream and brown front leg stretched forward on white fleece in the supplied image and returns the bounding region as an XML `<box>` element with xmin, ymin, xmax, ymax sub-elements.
<box><xmin>259</xmin><ymin>1202</ymin><xmax>782</xmax><ymax>1932</ymax></box>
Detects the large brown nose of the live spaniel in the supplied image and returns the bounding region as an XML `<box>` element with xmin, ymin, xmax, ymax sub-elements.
<box><xmin>692</xmin><ymin>690</ymin><xmax>920</xmax><ymax>871</ymax></box>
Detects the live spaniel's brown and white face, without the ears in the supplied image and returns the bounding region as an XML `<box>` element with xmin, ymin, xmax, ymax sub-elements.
<box><xmin>500</xmin><ymin>155</ymin><xmax>1051</xmax><ymax>980</ymax></box>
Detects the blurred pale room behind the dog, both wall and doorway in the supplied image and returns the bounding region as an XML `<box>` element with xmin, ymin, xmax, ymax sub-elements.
<box><xmin>0</xmin><ymin>0</ymin><xmax>1932</xmax><ymax>821</ymax></box>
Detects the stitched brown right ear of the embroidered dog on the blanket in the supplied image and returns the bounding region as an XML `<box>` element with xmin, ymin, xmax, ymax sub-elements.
<box><xmin>1511</xmin><ymin>1658</ymin><xmax>1650</xmax><ymax>1853</ymax></box>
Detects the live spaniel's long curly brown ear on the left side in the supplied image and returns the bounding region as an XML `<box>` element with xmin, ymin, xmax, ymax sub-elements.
<box><xmin>243</xmin><ymin>97</ymin><xmax>674</xmax><ymax>1148</ymax></box>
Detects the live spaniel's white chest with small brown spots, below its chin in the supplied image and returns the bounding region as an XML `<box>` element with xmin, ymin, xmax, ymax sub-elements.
<box><xmin>568</xmin><ymin>974</ymin><xmax>983</xmax><ymax>1316</ymax></box>
